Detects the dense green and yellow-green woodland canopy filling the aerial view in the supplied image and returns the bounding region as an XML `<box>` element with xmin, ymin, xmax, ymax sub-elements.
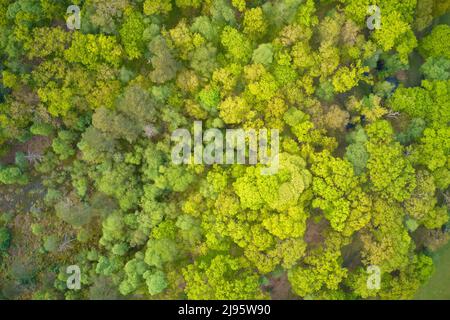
<box><xmin>0</xmin><ymin>0</ymin><xmax>450</xmax><ymax>299</ymax></box>
